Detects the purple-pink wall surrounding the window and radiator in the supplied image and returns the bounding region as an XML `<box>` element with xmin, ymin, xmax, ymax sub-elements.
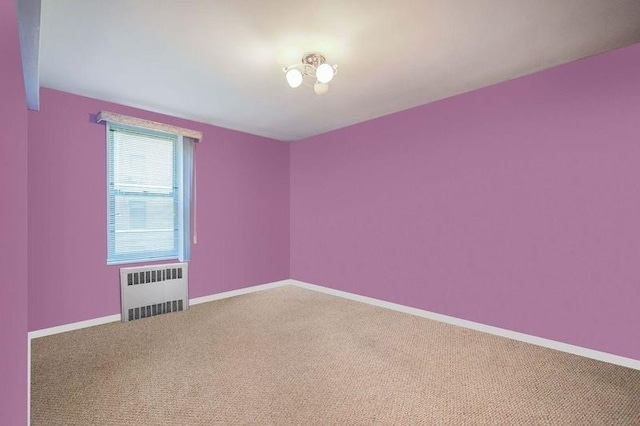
<box><xmin>29</xmin><ymin>89</ymin><xmax>289</xmax><ymax>330</ymax></box>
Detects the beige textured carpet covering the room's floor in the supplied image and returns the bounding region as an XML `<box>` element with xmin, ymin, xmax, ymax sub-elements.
<box><xmin>31</xmin><ymin>287</ymin><xmax>640</xmax><ymax>426</ymax></box>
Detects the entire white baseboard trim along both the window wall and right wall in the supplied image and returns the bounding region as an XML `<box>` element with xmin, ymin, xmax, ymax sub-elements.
<box><xmin>29</xmin><ymin>279</ymin><xmax>640</xmax><ymax>370</ymax></box>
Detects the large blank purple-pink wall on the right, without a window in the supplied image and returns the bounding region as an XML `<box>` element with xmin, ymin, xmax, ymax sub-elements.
<box><xmin>291</xmin><ymin>45</ymin><xmax>640</xmax><ymax>359</ymax></box>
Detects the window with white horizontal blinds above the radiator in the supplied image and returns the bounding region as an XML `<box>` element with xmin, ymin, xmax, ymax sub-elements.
<box><xmin>107</xmin><ymin>123</ymin><xmax>194</xmax><ymax>264</ymax></box>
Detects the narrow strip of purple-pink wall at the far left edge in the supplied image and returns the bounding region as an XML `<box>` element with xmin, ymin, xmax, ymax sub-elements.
<box><xmin>0</xmin><ymin>0</ymin><xmax>27</xmax><ymax>425</ymax></box>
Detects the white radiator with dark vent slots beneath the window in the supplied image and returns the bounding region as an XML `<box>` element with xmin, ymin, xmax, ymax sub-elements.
<box><xmin>120</xmin><ymin>263</ymin><xmax>189</xmax><ymax>322</ymax></box>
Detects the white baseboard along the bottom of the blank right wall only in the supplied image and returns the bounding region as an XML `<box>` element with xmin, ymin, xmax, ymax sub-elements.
<box><xmin>289</xmin><ymin>280</ymin><xmax>640</xmax><ymax>370</ymax></box>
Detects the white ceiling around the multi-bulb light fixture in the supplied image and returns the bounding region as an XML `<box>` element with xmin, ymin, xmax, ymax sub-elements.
<box><xmin>40</xmin><ymin>0</ymin><xmax>640</xmax><ymax>141</ymax></box>
